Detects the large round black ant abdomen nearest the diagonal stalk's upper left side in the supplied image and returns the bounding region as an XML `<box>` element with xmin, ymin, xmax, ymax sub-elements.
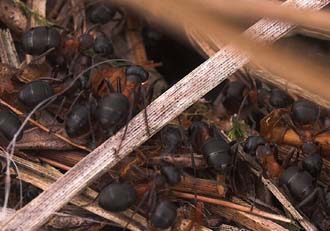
<box><xmin>95</xmin><ymin>93</ymin><xmax>129</xmax><ymax>132</ymax></box>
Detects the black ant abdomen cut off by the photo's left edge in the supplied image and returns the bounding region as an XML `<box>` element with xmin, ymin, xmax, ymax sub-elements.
<box><xmin>0</xmin><ymin>110</ymin><xmax>22</xmax><ymax>141</ymax></box>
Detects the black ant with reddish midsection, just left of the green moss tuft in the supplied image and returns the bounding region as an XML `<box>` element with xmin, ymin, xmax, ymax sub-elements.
<box><xmin>189</xmin><ymin>122</ymin><xmax>232</xmax><ymax>173</ymax></box>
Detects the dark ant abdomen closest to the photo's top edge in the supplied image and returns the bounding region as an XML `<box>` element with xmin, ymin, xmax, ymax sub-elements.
<box><xmin>89</xmin><ymin>4</ymin><xmax>117</xmax><ymax>24</ymax></box>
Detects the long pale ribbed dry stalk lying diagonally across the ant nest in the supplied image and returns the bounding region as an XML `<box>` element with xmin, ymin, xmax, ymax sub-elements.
<box><xmin>2</xmin><ymin>0</ymin><xmax>327</xmax><ymax>230</ymax></box>
